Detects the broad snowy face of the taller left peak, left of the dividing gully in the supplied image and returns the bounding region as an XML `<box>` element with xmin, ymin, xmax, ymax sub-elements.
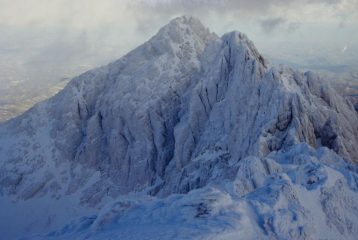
<box><xmin>0</xmin><ymin>18</ymin><xmax>218</xmax><ymax>201</ymax></box>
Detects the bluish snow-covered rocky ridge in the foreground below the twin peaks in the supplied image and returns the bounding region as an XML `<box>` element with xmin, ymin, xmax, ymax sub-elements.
<box><xmin>25</xmin><ymin>144</ymin><xmax>358</xmax><ymax>239</ymax></box>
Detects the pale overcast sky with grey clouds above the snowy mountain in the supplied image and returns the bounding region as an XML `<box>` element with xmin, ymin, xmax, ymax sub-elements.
<box><xmin>0</xmin><ymin>0</ymin><xmax>358</xmax><ymax>86</ymax></box>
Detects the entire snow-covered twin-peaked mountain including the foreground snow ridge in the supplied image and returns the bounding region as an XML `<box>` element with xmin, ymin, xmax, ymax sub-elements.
<box><xmin>0</xmin><ymin>17</ymin><xmax>358</xmax><ymax>239</ymax></box>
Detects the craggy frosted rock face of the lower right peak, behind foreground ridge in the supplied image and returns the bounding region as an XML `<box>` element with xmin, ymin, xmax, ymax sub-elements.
<box><xmin>161</xmin><ymin>32</ymin><xmax>358</xmax><ymax>195</ymax></box>
